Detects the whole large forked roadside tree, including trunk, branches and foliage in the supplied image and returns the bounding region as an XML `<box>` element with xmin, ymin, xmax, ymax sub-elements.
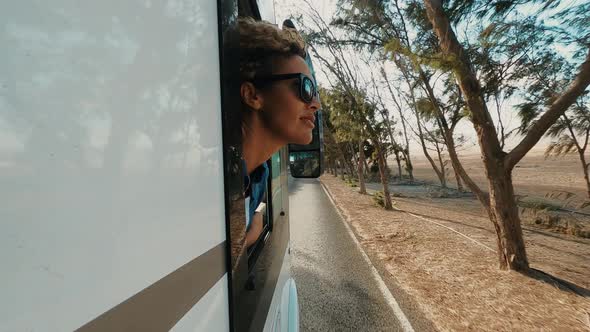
<box><xmin>333</xmin><ymin>0</ymin><xmax>590</xmax><ymax>271</ymax></box>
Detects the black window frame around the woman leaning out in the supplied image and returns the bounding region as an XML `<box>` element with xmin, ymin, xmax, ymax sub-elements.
<box><xmin>218</xmin><ymin>0</ymin><xmax>289</xmax><ymax>331</ymax></box>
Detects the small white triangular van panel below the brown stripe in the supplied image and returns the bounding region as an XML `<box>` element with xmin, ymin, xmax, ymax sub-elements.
<box><xmin>171</xmin><ymin>274</ymin><xmax>229</xmax><ymax>332</ymax></box>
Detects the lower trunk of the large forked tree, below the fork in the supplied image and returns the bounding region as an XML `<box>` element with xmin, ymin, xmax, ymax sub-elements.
<box><xmin>486</xmin><ymin>169</ymin><xmax>529</xmax><ymax>271</ymax></box>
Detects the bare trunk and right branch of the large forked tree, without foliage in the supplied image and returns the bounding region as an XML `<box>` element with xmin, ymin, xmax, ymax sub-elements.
<box><xmin>424</xmin><ymin>0</ymin><xmax>590</xmax><ymax>271</ymax></box>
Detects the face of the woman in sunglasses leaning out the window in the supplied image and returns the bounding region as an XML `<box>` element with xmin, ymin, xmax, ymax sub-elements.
<box><xmin>259</xmin><ymin>56</ymin><xmax>320</xmax><ymax>144</ymax></box>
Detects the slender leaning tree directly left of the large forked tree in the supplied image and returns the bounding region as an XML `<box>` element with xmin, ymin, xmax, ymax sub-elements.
<box><xmin>332</xmin><ymin>0</ymin><xmax>475</xmax><ymax>190</ymax></box>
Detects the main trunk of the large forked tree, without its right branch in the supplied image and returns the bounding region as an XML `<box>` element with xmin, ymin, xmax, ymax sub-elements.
<box><xmin>424</xmin><ymin>0</ymin><xmax>532</xmax><ymax>272</ymax></box>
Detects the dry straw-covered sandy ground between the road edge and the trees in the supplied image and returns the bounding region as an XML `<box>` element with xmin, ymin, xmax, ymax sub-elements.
<box><xmin>321</xmin><ymin>172</ymin><xmax>590</xmax><ymax>331</ymax></box>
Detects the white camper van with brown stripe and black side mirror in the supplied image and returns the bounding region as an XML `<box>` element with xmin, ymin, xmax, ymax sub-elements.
<box><xmin>0</xmin><ymin>0</ymin><xmax>321</xmax><ymax>332</ymax></box>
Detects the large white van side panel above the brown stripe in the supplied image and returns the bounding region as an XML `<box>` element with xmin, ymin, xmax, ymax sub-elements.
<box><xmin>0</xmin><ymin>0</ymin><xmax>225</xmax><ymax>331</ymax></box>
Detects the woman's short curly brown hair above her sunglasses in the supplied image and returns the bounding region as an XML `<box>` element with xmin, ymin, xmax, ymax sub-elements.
<box><xmin>231</xmin><ymin>18</ymin><xmax>306</xmax><ymax>82</ymax></box>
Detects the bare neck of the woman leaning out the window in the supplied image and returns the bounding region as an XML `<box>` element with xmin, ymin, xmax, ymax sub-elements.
<box><xmin>242</xmin><ymin>115</ymin><xmax>286</xmax><ymax>174</ymax></box>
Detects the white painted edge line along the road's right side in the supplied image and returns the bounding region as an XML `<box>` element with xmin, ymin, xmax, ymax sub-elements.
<box><xmin>319</xmin><ymin>181</ymin><xmax>414</xmax><ymax>332</ymax></box>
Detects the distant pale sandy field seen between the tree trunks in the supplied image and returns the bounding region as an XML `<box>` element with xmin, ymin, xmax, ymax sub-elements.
<box><xmin>410</xmin><ymin>151</ymin><xmax>587</xmax><ymax>208</ymax></box>
